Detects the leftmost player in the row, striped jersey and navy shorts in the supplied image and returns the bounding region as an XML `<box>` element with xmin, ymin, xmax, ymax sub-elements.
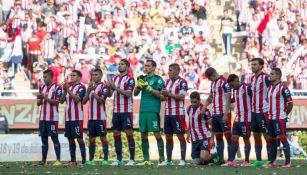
<box><xmin>37</xmin><ymin>69</ymin><xmax>62</xmax><ymax>166</ymax></box>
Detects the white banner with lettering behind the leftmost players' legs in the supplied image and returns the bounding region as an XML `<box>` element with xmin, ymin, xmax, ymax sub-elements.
<box><xmin>0</xmin><ymin>134</ymin><xmax>88</xmax><ymax>162</ymax></box>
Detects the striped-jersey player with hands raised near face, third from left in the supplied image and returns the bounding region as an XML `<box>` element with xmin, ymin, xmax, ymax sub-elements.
<box><xmin>83</xmin><ymin>68</ymin><xmax>109</xmax><ymax>166</ymax></box>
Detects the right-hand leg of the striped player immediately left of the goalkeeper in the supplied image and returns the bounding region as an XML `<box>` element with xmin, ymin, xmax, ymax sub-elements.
<box><xmin>122</xmin><ymin>112</ymin><xmax>135</xmax><ymax>165</ymax></box>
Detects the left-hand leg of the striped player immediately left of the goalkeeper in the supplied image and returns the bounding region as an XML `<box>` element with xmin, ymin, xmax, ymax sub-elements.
<box><xmin>112</xmin><ymin>113</ymin><xmax>123</xmax><ymax>165</ymax></box>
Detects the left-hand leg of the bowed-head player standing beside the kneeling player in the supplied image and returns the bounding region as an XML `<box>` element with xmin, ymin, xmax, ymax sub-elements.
<box><xmin>212</xmin><ymin>115</ymin><xmax>225</xmax><ymax>164</ymax></box>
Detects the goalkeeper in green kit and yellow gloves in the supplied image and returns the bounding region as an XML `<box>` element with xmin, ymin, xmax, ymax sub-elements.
<box><xmin>134</xmin><ymin>60</ymin><xmax>164</xmax><ymax>165</ymax></box>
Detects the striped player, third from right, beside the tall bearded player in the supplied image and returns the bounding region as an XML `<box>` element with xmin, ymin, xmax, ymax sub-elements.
<box><xmin>226</xmin><ymin>74</ymin><xmax>252</xmax><ymax>166</ymax></box>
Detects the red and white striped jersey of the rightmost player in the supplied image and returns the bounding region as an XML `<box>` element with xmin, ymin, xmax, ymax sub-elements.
<box><xmin>268</xmin><ymin>82</ymin><xmax>292</xmax><ymax>120</ymax></box>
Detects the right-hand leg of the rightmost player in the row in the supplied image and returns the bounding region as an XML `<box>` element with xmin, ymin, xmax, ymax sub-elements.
<box><xmin>275</xmin><ymin>119</ymin><xmax>291</xmax><ymax>168</ymax></box>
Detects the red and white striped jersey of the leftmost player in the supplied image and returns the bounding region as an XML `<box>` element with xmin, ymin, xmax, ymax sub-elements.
<box><xmin>39</xmin><ymin>83</ymin><xmax>62</xmax><ymax>121</ymax></box>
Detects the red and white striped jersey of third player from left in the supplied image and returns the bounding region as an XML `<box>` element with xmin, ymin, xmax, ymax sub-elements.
<box><xmin>88</xmin><ymin>83</ymin><xmax>108</xmax><ymax>120</ymax></box>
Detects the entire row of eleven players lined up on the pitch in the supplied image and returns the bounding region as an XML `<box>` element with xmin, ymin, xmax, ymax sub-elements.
<box><xmin>37</xmin><ymin>58</ymin><xmax>293</xmax><ymax>168</ymax></box>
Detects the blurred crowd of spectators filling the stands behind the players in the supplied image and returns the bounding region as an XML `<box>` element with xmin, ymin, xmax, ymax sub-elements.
<box><xmin>0</xmin><ymin>0</ymin><xmax>307</xmax><ymax>95</ymax></box>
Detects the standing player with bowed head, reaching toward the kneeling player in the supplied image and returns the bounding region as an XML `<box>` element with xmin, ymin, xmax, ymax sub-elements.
<box><xmin>203</xmin><ymin>67</ymin><xmax>231</xmax><ymax>165</ymax></box>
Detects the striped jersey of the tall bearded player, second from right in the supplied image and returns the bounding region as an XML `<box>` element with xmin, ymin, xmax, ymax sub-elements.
<box><xmin>251</xmin><ymin>72</ymin><xmax>271</xmax><ymax>113</ymax></box>
